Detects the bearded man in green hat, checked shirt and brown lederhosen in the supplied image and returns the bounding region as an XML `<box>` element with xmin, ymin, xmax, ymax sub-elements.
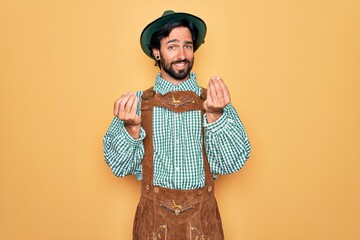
<box><xmin>104</xmin><ymin>11</ymin><xmax>250</xmax><ymax>240</ymax></box>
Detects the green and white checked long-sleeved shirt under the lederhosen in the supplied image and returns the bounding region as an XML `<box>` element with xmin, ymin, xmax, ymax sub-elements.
<box><xmin>104</xmin><ymin>73</ymin><xmax>251</xmax><ymax>189</ymax></box>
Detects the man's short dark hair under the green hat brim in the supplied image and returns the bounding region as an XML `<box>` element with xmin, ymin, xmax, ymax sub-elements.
<box><xmin>149</xmin><ymin>19</ymin><xmax>199</xmax><ymax>63</ymax></box>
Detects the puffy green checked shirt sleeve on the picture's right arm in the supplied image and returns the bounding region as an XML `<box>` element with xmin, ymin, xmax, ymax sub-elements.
<box><xmin>204</xmin><ymin>104</ymin><xmax>251</xmax><ymax>174</ymax></box>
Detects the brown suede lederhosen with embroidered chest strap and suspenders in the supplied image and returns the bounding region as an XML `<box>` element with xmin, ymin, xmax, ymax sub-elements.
<box><xmin>133</xmin><ymin>88</ymin><xmax>224</xmax><ymax>240</ymax></box>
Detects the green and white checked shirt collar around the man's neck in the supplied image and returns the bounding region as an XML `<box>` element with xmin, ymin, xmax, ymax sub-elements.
<box><xmin>154</xmin><ymin>73</ymin><xmax>201</xmax><ymax>95</ymax></box>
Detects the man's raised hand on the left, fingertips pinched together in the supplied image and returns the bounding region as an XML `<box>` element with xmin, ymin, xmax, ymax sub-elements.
<box><xmin>114</xmin><ymin>92</ymin><xmax>141</xmax><ymax>139</ymax></box>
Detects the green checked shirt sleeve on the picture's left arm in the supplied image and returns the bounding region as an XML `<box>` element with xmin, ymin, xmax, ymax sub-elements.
<box><xmin>103</xmin><ymin>92</ymin><xmax>146</xmax><ymax>179</ymax></box>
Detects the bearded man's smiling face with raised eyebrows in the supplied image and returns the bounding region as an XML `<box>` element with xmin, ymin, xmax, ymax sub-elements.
<box><xmin>159</xmin><ymin>27</ymin><xmax>194</xmax><ymax>84</ymax></box>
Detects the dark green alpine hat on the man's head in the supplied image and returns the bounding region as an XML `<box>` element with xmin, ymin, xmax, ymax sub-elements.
<box><xmin>140</xmin><ymin>10</ymin><xmax>206</xmax><ymax>59</ymax></box>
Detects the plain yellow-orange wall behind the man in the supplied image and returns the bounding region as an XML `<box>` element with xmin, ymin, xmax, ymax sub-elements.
<box><xmin>0</xmin><ymin>0</ymin><xmax>360</xmax><ymax>240</ymax></box>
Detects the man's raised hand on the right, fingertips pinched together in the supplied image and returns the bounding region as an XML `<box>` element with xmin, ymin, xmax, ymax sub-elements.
<box><xmin>204</xmin><ymin>76</ymin><xmax>231</xmax><ymax>123</ymax></box>
